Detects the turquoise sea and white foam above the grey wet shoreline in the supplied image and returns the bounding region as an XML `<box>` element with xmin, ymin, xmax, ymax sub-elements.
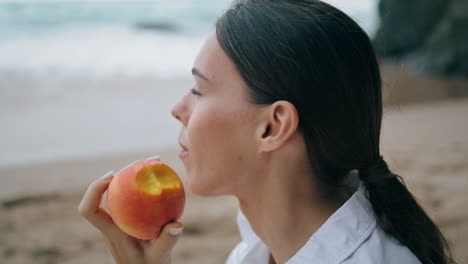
<box><xmin>0</xmin><ymin>0</ymin><xmax>377</xmax><ymax>78</ymax></box>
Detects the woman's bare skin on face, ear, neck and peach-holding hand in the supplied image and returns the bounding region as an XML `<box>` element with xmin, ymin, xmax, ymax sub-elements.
<box><xmin>79</xmin><ymin>34</ymin><xmax>349</xmax><ymax>264</ymax></box>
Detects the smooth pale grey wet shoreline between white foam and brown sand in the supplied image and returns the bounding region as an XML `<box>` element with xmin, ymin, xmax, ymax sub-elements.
<box><xmin>0</xmin><ymin>71</ymin><xmax>192</xmax><ymax>167</ymax></box>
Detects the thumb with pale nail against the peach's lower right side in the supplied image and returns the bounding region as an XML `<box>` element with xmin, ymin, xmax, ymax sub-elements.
<box><xmin>145</xmin><ymin>222</ymin><xmax>184</xmax><ymax>263</ymax></box>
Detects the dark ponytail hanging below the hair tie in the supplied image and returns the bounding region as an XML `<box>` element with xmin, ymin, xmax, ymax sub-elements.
<box><xmin>359</xmin><ymin>156</ymin><xmax>455</xmax><ymax>264</ymax></box>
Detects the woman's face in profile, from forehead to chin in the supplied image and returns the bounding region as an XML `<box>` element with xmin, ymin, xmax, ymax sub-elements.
<box><xmin>172</xmin><ymin>34</ymin><xmax>262</xmax><ymax>195</ymax></box>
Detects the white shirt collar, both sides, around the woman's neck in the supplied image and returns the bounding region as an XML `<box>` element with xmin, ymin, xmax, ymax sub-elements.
<box><xmin>237</xmin><ymin>184</ymin><xmax>376</xmax><ymax>264</ymax></box>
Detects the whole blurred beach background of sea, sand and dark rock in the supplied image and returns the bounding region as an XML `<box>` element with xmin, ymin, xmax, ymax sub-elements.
<box><xmin>0</xmin><ymin>0</ymin><xmax>468</xmax><ymax>264</ymax></box>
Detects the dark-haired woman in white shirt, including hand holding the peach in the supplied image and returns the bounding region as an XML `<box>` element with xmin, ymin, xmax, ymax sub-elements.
<box><xmin>79</xmin><ymin>0</ymin><xmax>452</xmax><ymax>264</ymax></box>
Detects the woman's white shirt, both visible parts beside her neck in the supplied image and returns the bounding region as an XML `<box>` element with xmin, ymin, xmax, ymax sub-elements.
<box><xmin>226</xmin><ymin>184</ymin><xmax>421</xmax><ymax>264</ymax></box>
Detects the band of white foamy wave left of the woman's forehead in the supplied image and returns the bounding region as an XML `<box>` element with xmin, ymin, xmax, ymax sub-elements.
<box><xmin>0</xmin><ymin>27</ymin><xmax>205</xmax><ymax>79</ymax></box>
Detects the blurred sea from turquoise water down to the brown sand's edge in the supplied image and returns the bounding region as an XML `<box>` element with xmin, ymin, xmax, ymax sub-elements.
<box><xmin>0</xmin><ymin>0</ymin><xmax>377</xmax><ymax>167</ymax></box>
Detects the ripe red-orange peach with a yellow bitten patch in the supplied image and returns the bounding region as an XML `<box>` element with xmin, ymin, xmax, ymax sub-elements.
<box><xmin>107</xmin><ymin>160</ymin><xmax>185</xmax><ymax>240</ymax></box>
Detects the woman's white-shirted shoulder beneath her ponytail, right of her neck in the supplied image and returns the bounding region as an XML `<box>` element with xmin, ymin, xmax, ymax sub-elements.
<box><xmin>287</xmin><ymin>185</ymin><xmax>421</xmax><ymax>264</ymax></box>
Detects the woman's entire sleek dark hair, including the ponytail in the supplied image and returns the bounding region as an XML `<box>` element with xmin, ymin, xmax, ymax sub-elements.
<box><xmin>216</xmin><ymin>0</ymin><xmax>453</xmax><ymax>264</ymax></box>
